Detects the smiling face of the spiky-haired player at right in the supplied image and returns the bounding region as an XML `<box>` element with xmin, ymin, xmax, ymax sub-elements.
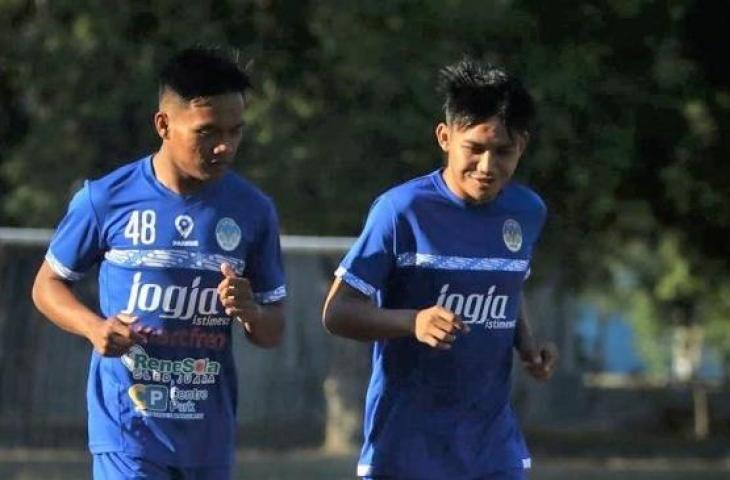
<box><xmin>436</xmin><ymin>117</ymin><xmax>527</xmax><ymax>203</ymax></box>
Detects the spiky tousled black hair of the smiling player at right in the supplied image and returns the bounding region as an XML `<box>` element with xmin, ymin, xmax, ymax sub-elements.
<box><xmin>439</xmin><ymin>57</ymin><xmax>535</xmax><ymax>135</ymax></box>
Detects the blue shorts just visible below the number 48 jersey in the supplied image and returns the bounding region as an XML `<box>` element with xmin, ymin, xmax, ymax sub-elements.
<box><xmin>93</xmin><ymin>452</ymin><xmax>231</xmax><ymax>480</ymax></box>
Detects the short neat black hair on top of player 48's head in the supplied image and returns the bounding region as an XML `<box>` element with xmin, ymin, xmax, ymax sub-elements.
<box><xmin>158</xmin><ymin>46</ymin><xmax>251</xmax><ymax>100</ymax></box>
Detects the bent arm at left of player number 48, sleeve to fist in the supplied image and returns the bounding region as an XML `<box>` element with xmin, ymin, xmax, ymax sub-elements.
<box><xmin>32</xmin><ymin>261</ymin><xmax>149</xmax><ymax>357</ymax></box>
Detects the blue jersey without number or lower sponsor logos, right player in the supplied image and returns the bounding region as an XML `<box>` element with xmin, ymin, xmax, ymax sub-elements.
<box><xmin>336</xmin><ymin>171</ymin><xmax>546</xmax><ymax>480</ymax></box>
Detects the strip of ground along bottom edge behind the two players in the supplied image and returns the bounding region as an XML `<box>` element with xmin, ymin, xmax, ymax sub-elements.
<box><xmin>0</xmin><ymin>451</ymin><xmax>730</xmax><ymax>480</ymax></box>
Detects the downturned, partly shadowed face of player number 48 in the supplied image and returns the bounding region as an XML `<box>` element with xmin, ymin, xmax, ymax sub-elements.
<box><xmin>163</xmin><ymin>93</ymin><xmax>244</xmax><ymax>182</ymax></box>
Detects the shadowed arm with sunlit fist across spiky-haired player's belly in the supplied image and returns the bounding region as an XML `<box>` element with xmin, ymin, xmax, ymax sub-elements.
<box><xmin>322</xmin><ymin>277</ymin><xmax>468</xmax><ymax>349</ymax></box>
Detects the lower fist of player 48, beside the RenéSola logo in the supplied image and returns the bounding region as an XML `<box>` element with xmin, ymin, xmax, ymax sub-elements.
<box><xmin>87</xmin><ymin>313</ymin><xmax>153</xmax><ymax>357</ymax></box>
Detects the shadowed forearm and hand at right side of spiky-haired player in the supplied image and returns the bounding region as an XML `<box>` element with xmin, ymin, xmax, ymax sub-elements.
<box><xmin>515</xmin><ymin>294</ymin><xmax>558</xmax><ymax>380</ymax></box>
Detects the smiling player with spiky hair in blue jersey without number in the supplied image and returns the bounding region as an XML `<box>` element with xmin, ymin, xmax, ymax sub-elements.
<box><xmin>323</xmin><ymin>59</ymin><xmax>557</xmax><ymax>480</ymax></box>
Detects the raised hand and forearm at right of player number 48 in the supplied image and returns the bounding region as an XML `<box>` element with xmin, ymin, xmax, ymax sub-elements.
<box><xmin>218</xmin><ymin>263</ymin><xmax>284</xmax><ymax>348</ymax></box>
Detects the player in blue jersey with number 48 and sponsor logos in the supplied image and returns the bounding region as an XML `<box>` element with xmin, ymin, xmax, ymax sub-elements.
<box><xmin>33</xmin><ymin>48</ymin><xmax>286</xmax><ymax>480</ymax></box>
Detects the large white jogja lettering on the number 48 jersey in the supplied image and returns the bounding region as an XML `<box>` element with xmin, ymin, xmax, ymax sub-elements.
<box><xmin>122</xmin><ymin>272</ymin><xmax>219</xmax><ymax>320</ymax></box>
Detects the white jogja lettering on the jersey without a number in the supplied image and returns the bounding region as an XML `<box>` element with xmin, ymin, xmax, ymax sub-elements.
<box><xmin>437</xmin><ymin>283</ymin><xmax>513</xmax><ymax>328</ymax></box>
